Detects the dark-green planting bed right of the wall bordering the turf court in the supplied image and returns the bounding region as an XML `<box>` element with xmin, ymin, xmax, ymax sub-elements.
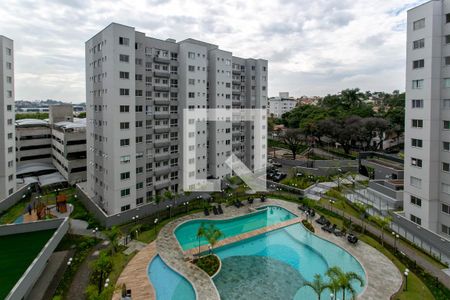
<box><xmin>53</xmin><ymin>234</ymin><xmax>99</xmax><ymax>300</ymax></box>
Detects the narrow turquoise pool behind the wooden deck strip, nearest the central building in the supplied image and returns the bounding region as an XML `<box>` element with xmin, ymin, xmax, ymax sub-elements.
<box><xmin>175</xmin><ymin>206</ymin><xmax>296</xmax><ymax>251</ymax></box>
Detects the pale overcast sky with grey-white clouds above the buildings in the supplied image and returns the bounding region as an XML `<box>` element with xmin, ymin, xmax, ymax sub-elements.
<box><xmin>0</xmin><ymin>0</ymin><xmax>426</xmax><ymax>103</ymax></box>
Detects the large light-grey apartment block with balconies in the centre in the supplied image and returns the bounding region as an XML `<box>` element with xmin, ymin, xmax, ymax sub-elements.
<box><xmin>86</xmin><ymin>23</ymin><xmax>268</xmax><ymax>214</ymax></box>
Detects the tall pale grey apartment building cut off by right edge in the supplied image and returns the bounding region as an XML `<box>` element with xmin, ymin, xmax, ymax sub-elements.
<box><xmin>404</xmin><ymin>0</ymin><xmax>450</xmax><ymax>238</ymax></box>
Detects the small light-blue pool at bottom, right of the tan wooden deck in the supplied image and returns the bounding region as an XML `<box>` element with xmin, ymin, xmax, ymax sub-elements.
<box><xmin>148</xmin><ymin>255</ymin><xmax>196</xmax><ymax>300</ymax></box>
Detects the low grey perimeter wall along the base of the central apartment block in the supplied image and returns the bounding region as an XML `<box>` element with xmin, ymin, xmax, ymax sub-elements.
<box><xmin>77</xmin><ymin>184</ymin><xmax>210</xmax><ymax>228</ymax></box>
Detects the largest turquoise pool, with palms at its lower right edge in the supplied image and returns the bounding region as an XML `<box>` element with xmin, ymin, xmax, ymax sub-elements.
<box><xmin>214</xmin><ymin>224</ymin><xmax>365</xmax><ymax>300</ymax></box>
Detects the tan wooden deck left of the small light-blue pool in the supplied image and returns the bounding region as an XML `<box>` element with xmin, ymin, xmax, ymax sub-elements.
<box><xmin>112</xmin><ymin>242</ymin><xmax>156</xmax><ymax>300</ymax></box>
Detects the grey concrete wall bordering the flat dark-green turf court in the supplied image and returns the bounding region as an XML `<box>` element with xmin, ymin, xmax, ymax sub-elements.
<box><xmin>0</xmin><ymin>218</ymin><xmax>69</xmax><ymax>300</ymax></box>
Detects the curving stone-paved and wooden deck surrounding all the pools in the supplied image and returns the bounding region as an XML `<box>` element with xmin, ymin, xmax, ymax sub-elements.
<box><xmin>113</xmin><ymin>199</ymin><xmax>402</xmax><ymax>300</ymax></box>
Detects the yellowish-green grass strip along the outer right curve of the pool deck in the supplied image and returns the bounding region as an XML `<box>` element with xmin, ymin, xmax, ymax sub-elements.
<box><xmin>359</xmin><ymin>235</ymin><xmax>435</xmax><ymax>300</ymax></box>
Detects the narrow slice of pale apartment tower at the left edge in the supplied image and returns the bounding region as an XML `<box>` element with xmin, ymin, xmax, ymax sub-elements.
<box><xmin>0</xmin><ymin>35</ymin><xmax>16</xmax><ymax>200</ymax></box>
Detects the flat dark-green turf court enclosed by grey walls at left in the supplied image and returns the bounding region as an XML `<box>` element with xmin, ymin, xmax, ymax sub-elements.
<box><xmin>0</xmin><ymin>229</ymin><xmax>55</xmax><ymax>299</ymax></box>
